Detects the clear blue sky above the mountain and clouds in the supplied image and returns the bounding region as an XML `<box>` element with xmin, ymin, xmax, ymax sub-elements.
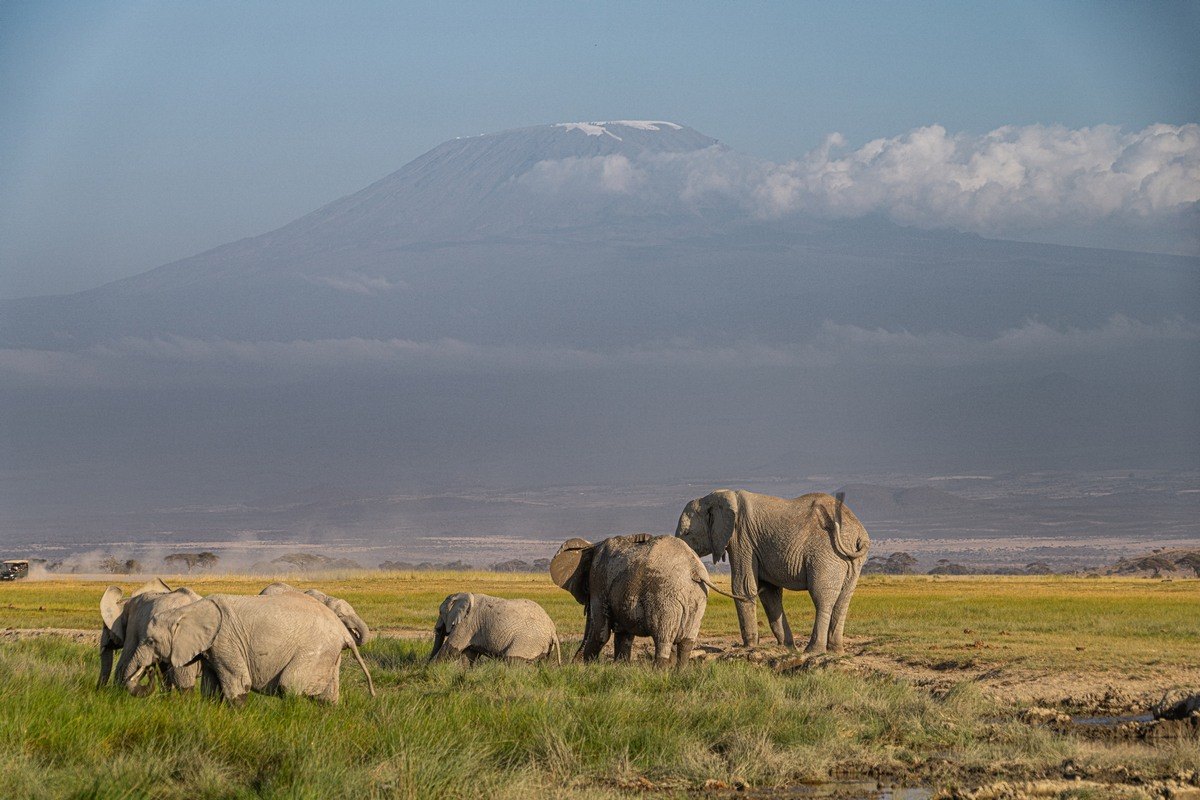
<box><xmin>0</xmin><ymin>2</ymin><xmax>1200</xmax><ymax>296</ymax></box>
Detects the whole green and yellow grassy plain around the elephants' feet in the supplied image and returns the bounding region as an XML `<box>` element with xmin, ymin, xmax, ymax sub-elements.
<box><xmin>0</xmin><ymin>572</ymin><xmax>1200</xmax><ymax>800</ymax></box>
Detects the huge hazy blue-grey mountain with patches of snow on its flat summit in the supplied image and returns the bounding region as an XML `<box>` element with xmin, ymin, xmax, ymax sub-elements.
<box><xmin>0</xmin><ymin>120</ymin><xmax>1200</xmax><ymax>525</ymax></box>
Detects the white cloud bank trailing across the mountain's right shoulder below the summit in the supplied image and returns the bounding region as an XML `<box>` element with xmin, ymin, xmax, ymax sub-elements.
<box><xmin>518</xmin><ymin>124</ymin><xmax>1200</xmax><ymax>253</ymax></box>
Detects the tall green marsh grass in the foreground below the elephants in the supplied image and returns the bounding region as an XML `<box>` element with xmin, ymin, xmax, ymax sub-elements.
<box><xmin>0</xmin><ymin>637</ymin><xmax>1200</xmax><ymax>798</ymax></box>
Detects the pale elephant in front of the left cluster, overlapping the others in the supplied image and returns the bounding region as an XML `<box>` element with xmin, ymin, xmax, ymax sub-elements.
<box><xmin>133</xmin><ymin>591</ymin><xmax>376</xmax><ymax>704</ymax></box>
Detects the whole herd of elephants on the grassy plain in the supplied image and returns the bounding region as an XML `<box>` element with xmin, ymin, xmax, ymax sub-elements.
<box><xmin>91</xmin><ymin>489</ymin><xmax>870</xmax><ymax>703</ymax></box>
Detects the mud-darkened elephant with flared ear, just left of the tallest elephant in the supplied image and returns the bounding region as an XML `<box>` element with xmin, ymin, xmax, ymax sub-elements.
<box><xmin>556</xmin><ymin>534</ymin><xmax>708</xmax><ymax>667</ymax></box>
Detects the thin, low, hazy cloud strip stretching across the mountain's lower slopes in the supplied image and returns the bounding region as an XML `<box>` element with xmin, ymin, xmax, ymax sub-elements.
<box><xmin>0</xmin><ymin>314</ymin><xmax>1200</xmax><ymax>387</ymax></box>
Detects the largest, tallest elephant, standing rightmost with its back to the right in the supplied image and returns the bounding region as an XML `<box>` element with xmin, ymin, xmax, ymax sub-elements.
<box><xmin>676</xmin><ymin>489</ymin><xmax>870</xmax><ymax>654</ymax></box>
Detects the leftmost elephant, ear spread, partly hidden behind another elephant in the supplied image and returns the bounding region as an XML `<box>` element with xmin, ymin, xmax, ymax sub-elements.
<box><xmin>96</xmin><ymin>578</ymin><xmax>200</xmax><ymax>697</ymax></box>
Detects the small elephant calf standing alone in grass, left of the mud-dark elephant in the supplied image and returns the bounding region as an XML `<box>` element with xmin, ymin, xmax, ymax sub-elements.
<box><xmin>430</xmin><ymin>591</ymin><xmax>563</xmax><ymax>663</ymax></box>
